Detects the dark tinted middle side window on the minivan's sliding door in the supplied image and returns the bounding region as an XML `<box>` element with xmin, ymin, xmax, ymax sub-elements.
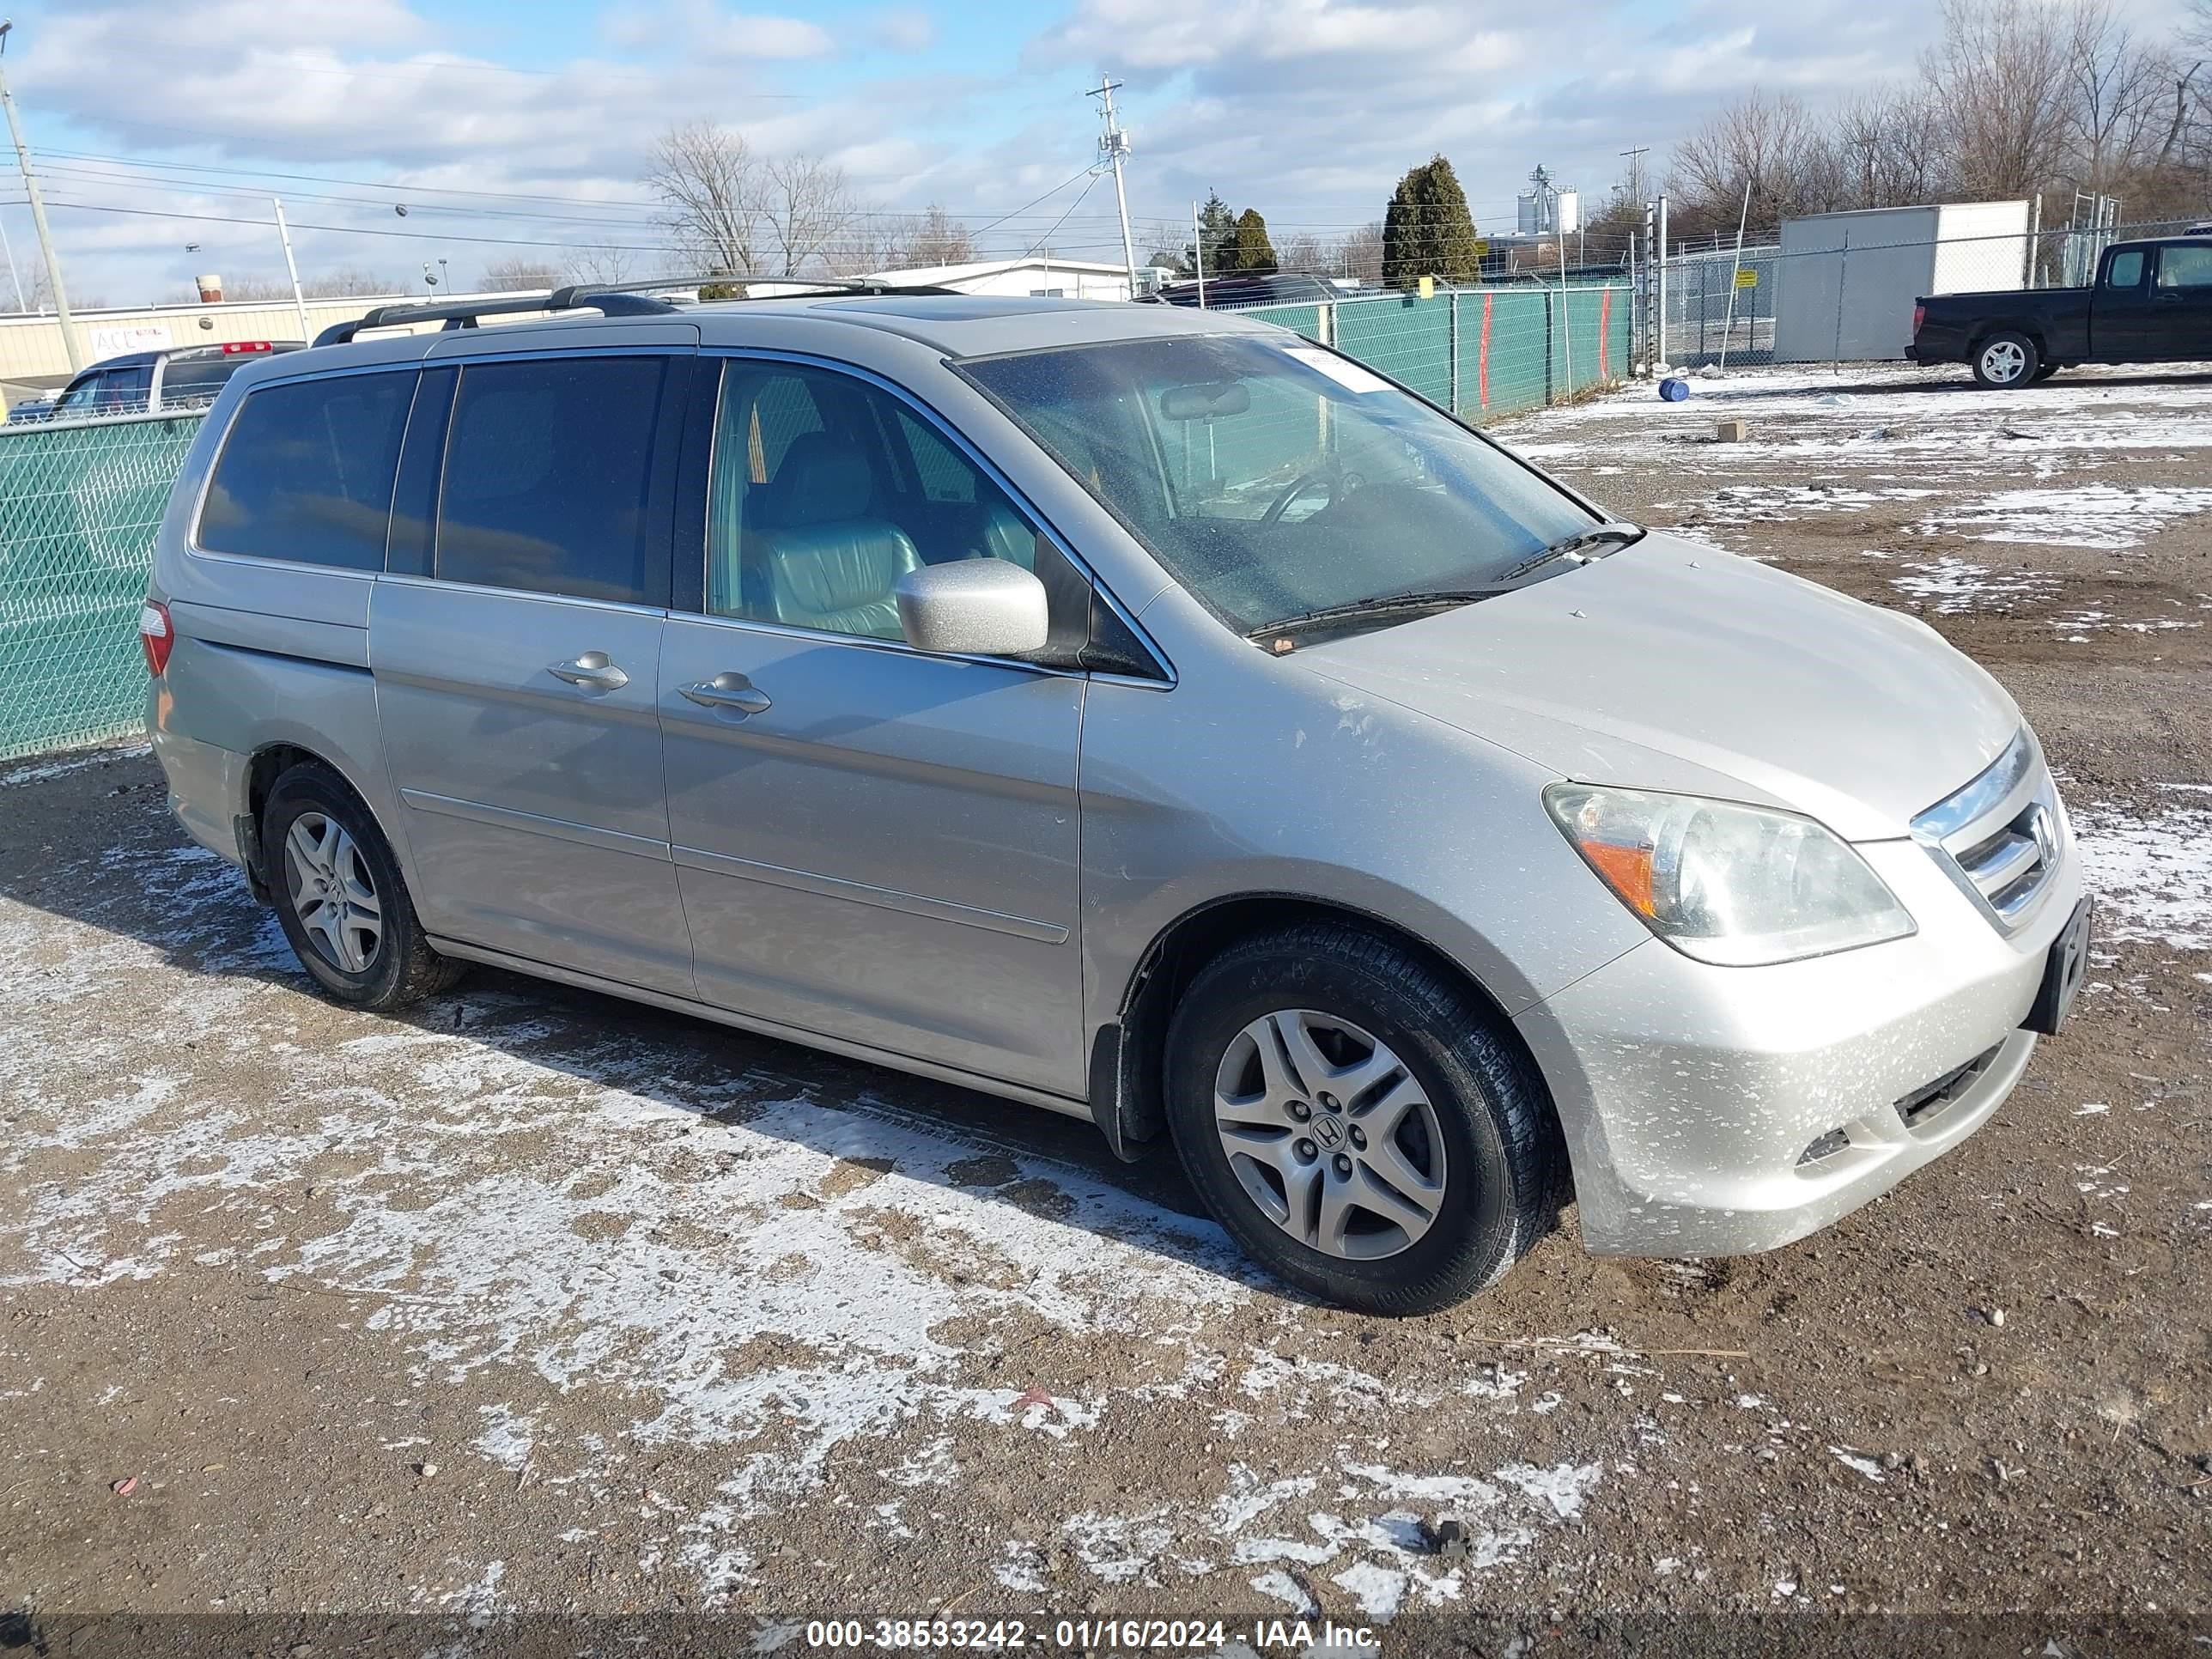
<box><xmin>435</xmin><ymin>356</ymin><xmax>668</xmax><ymax>604</ymax></box>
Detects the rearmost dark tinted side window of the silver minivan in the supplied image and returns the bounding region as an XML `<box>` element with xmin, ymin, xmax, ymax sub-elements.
<box><xmin>195</xmin><ymin>369</ymin><xmax>416</xmax><ymax>571</ymax></box>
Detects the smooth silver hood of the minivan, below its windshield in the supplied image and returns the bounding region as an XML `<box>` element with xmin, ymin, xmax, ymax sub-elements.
<box><xmin>1291</xmin><ymin>533</ymin><xmax>2020</xmax><ymax>841</ymax></box>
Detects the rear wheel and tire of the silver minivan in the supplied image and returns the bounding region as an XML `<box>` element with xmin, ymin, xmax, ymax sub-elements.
<box><xmin>261</xmin><ymin>761</ymin><xmax>462</xmax><ymax>1013</ymax></box>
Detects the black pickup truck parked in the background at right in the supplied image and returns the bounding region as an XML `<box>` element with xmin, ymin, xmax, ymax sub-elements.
<box><xmin>1905</xmin><ymin>237</ymin><xmax>2212</xmax><ymax>387</ymax></box>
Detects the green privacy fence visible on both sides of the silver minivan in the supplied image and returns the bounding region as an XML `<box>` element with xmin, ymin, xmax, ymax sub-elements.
<box><xmin>0</xmin><ymin>288</ymin><xmax>1635</xmax><ymax>761</ymax></box>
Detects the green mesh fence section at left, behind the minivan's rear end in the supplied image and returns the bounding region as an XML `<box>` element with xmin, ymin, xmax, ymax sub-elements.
<box><xmin>0</xmin><ymin>414</ymin><xmax>201</xmax><ymax>761</ymax></box>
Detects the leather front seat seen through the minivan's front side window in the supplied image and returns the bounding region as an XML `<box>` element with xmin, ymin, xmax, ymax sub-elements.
<box><xmin>761</xmin><ymin>434</ymin><xmax>922</xmax><ymax>639</ymax></box>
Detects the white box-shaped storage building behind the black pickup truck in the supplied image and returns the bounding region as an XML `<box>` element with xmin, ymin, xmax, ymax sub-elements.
<box><xmin>1774</xmin><ymin>201</ymin><xmax>2028</xmax><ymax>362</ymax></box>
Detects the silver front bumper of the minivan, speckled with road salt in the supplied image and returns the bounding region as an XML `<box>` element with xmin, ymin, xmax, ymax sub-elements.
<box><xmin>1516</xmin><ymin>836</ymin><xmax>2081</xmax><ymax>1256</ymax></box>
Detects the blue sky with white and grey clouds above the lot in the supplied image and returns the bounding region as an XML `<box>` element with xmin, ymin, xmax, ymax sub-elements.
<box><xmin>0</xmin><ymin>0</ymin><xmax>2166</xmax><ymax>303</ymax></box>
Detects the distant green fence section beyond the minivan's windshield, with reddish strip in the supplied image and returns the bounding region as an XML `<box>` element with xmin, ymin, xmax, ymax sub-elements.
<box><xmin>1239</xmin><ymin>283</ymin><xmax>1635</xmax><ymax>420</ymax></box>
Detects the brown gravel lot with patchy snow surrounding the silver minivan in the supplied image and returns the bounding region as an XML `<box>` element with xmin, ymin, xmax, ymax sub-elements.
<box><xmin>0</xmin><ymin>358</ymin><xmax>2212</xmax><ymax>1659</ymax></box>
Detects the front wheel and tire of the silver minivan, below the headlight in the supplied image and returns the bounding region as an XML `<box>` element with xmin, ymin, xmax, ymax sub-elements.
<box><xmin>1166</xmin><ymin>922</ymin><xmax>1558</xmax><ymax>1314</ymax></box>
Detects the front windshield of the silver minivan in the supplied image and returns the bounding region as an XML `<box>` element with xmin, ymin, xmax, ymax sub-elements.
<box><xmin>957</xmin><ymin>334</ymin><xmax>1599</xmax><ymax>633</ymax></box>
